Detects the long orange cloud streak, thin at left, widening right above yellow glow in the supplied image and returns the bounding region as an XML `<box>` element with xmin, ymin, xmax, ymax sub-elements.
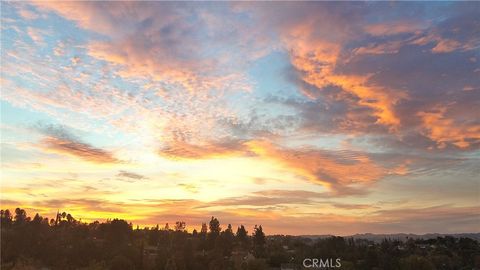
<box><xmin>159</xmin><ymin>139</ymin><xmax>408</xmax><ymax>195</ymax></box>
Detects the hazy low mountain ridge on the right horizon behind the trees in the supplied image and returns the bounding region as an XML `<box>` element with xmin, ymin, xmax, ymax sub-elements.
<box><xmin>301</xmin><ymin>233</ymin><xmax>480</xmax><ymax>243</ymax></box>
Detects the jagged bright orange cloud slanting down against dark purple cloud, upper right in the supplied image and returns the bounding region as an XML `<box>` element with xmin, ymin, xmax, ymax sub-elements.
<box><xmin>285</xmin><ymin>22</ymin><xmax>407</xmax><ymax>130</ymax></box>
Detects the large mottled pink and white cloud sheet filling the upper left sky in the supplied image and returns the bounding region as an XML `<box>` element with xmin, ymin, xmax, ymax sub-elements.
<box><xmin>2</xmin><ymin>1</ymin><xmax>259</xmax><ymax>152</ymax></box>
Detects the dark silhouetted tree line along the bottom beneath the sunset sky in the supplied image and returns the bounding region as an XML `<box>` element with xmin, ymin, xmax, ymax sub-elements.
<box><xmin>0</xmin><ymin>208</ymin><xmax>480</xmax><ymax>270</ymax></box>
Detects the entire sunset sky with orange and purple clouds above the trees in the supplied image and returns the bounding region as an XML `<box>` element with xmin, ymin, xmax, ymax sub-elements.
<box><xmin>0</xmin><ymin>1</ymin><xmax>480</xmax><ymax>235</ymax></box>
